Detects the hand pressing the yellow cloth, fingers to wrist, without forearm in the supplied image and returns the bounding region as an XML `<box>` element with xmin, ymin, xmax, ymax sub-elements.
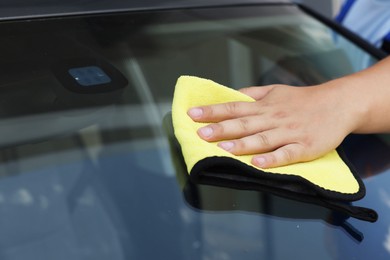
<box><xmin>188</xmin><ymin>82</ymin><xmax>355</xmax><ymax>168</ymax></box>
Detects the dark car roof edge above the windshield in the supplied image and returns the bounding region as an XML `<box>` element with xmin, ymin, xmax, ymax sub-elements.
<box><xmin>0</xmin><ymin>0</ymin><xmax>291</xmax><ymax>20</ymax></box>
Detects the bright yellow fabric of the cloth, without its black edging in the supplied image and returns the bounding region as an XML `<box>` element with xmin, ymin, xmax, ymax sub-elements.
<box><xmin>172</xmin><ymin>76</ymin><xmax>360</xmax><ymax>194</ymax></box>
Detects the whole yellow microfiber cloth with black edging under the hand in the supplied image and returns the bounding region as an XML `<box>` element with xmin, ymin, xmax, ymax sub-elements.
<box><xmin>172</xmin><ymin>76</ymin><xmax>377</xmax><ymax>222</ymax></box>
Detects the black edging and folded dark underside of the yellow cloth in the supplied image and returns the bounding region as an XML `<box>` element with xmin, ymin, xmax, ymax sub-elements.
<box><xmin>189</xmin><ymin>154</ymin><xmax>378</xmax><ymax>222</ymax></box>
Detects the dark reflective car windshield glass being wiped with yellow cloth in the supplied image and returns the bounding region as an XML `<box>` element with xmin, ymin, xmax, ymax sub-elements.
<box><xmin>0</xmin><ymin>5</ymin><xmax>390</xmax><ymax>260</ymax></box>
